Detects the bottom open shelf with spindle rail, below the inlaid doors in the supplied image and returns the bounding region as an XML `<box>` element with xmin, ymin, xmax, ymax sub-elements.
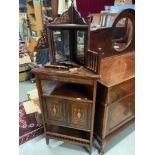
<box><xmin>46</xmin><ymin>124</ymin><xmax>90</xmax><ymax>146</ymax></box>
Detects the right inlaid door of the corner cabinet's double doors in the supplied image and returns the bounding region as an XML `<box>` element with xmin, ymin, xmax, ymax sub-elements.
<box><xmin>69</xmin><ymin>102</ymin><xmax>91</xmax><ymax>130</ymax></box>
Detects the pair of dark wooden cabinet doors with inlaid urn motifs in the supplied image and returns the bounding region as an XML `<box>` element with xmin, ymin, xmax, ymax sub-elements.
<box><xmin>44</xmin><ymin>97</ymin><xmax>92</xmax><ymax>131</ymax></box>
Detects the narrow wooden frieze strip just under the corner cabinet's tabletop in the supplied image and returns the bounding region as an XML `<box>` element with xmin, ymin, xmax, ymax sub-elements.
<box><xmin>37</xmin><ymin>74</ymin><xmax>93</xmax><ymax>85</ymax></box>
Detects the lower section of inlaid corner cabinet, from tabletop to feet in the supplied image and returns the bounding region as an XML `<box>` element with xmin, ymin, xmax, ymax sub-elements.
<box><xmin>33</xmin><ymin>67</ymin><xmax>99</xmax><ymax>154</ymax></box>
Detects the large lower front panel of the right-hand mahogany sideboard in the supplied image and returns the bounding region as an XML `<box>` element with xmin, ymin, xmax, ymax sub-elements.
<box><xmin>106</xmin><ymin>93</ymin><xmax>135</xmax><ymax>135</ymax></box>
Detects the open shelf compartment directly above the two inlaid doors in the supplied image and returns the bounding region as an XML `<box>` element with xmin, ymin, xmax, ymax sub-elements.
<box><xmin>43</xmin><ymin>81</ymin><xmax>93</xmax><ymax>103</ymax></box>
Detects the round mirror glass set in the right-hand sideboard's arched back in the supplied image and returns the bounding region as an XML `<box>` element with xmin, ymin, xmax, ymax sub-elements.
<box><xmin>112</xmin><ymin>17</ymin><xmax>133</xmax><ymax>52</ymax></box>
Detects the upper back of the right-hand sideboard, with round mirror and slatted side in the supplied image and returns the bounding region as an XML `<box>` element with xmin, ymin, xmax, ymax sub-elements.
<box><xmin>86</xmin><ymin>9</ymin><xmax>135</xmax><ymax>74</ymax></box>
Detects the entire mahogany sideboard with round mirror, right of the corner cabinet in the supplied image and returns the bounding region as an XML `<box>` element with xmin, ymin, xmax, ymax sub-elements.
<box><xmin>87</xmin><ymin>6</ymin><xmax>135</xmax><ymax>155</ymax></box>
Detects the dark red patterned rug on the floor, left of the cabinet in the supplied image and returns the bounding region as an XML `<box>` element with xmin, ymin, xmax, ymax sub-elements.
<box><xmin>19</xmin><ymin>102</ymin><xmax>44</xmax><ymax>144</ymax></box>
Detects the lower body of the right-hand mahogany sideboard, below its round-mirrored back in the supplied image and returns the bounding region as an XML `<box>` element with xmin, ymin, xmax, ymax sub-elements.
<box><xmin>94</xmin><ymin>53</ymin><xmax>135</xmax><ymax>155</ymax></box>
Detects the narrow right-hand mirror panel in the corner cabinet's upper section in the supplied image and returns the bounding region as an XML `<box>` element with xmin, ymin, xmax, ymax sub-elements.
<box><xmin>76</xmin><ymin>31</ymin><xmax>86</xmax><ymax>64</ymax></box>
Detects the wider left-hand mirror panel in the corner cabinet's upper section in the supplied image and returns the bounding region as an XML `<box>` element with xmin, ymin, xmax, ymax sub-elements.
<box><xmin>52</xmin><ymin>30</ymin><xmax>70</xmax><ymax>62</ymax></box>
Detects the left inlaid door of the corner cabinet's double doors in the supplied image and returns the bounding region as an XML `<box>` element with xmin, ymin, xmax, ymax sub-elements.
<box><xmin>44</xmin><ymin>98</ymin><xmax>66</xmax><ymax>125</ymax></box>
